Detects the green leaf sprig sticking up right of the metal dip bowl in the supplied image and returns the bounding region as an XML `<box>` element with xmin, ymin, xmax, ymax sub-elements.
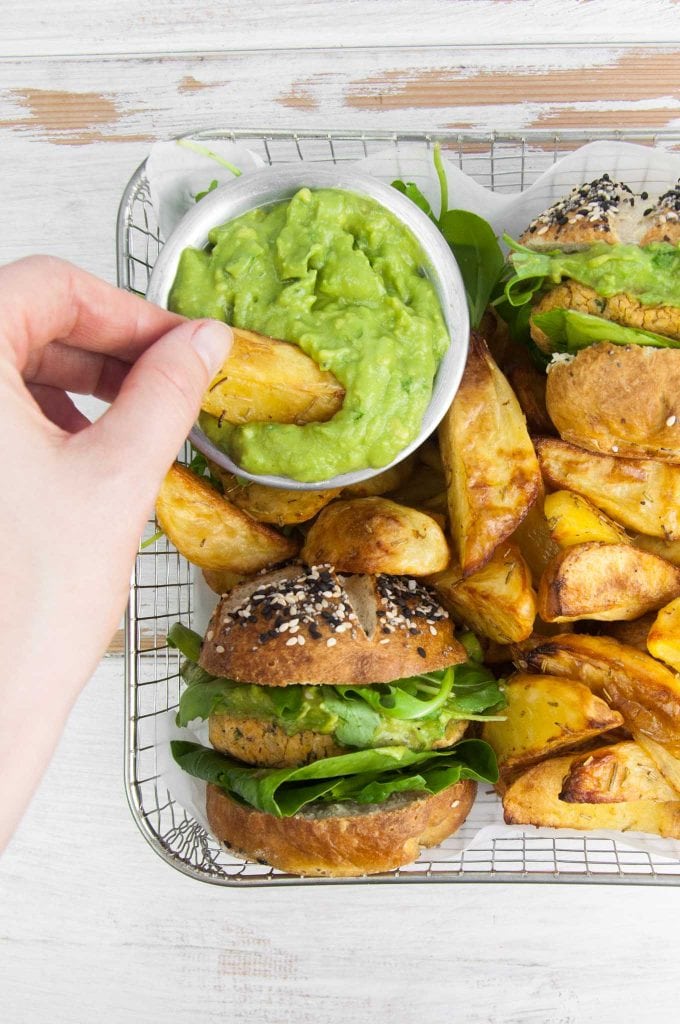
<box><xmin>392</xmin><ymin>142</ymin><xmax>505</xmax><ymax>328</ymax></box>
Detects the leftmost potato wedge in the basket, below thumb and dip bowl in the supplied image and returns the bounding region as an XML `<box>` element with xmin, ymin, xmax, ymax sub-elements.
<box><xmin>156</xmin><ymin>463</ymin><xmax>298</xmax><ymax>574</ymax></box>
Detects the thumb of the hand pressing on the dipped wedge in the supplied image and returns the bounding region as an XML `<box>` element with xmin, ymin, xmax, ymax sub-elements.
<box><xmin>87</xmin><ymin>321</ymin><xmax>233</xmax><ymax>491</ymax></box>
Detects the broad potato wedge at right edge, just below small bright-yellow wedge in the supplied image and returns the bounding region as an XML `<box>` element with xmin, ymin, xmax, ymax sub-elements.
<box><xmin>539</xmin><ymin>543</ymin><xmax>680</xmax><ymax>623</ymax></box>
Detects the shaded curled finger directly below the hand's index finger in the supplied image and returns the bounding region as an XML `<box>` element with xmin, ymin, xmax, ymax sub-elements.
<box><xmin>24</xmin><ymin>341</ymin><xmax>130</xmax><ymax>401</ymax></box>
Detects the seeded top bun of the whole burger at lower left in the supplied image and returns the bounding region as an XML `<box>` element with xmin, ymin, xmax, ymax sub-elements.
<box><xmin>199</xmin><ymin>562</ymin><xmax>467</xmax><ymax>686</ymax></box>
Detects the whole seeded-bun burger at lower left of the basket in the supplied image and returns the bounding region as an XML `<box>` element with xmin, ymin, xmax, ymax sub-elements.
<box><xmin>169</xmin><ymin>562</ymin><xmax>504</xmax><ymax>877</ymax></box>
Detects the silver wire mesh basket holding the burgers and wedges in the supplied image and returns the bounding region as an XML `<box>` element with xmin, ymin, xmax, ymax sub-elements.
<box><xmin>118</xmin><ymin>130</ymin><xmax>680</xmax><ymax>886</ymax></box>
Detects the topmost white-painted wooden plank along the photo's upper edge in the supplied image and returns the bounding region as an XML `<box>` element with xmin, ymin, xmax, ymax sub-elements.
<box><xmin>0</xmin><ymin>0</ymin><xmax>680</xmax><ymax>56</ymax></box>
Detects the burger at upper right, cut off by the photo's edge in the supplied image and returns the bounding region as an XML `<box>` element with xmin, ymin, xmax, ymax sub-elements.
<box><xmin>498</xmin><ymin>174</ymin><xmax>680</xmax><ymax>463</ymax></box>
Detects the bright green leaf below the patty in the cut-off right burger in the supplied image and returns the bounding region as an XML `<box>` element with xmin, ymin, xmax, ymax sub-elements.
<box><xmin>532</xmin><ymin>308</ymin><xmax>680</xmax><ymax>352</ymax></box>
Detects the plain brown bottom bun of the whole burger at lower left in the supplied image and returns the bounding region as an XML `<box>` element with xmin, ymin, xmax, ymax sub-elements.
<box><xmin>207</xmin><ymin>779</ymin><xmax>477</xmax><ymax>878</ymax></box>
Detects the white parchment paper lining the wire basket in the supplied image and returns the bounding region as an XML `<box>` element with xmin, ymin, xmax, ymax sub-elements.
<box><xmin>145</xmin><ymin>139</ymin><xmax>680</xmax><ymax>859</ymax></box>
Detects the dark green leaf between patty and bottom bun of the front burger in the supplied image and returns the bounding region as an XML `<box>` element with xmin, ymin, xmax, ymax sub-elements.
<box><xmin>171</xmin><ymin>739</ymin><xmax>498</xmax><ymax>817</ymax></box>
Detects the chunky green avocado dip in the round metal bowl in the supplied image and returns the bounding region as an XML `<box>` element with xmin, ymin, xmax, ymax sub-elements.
<box><xmin>169</xmin><ymin>188</ymin><xmax>449</xmax><ymax>482</ymax></box>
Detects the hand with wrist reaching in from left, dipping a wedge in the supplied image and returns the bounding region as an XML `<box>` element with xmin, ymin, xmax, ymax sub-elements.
<box><xmin>0</xmin><ymin>256</ymin><xmax>230</xmax><ymax>849</ymax></box>
